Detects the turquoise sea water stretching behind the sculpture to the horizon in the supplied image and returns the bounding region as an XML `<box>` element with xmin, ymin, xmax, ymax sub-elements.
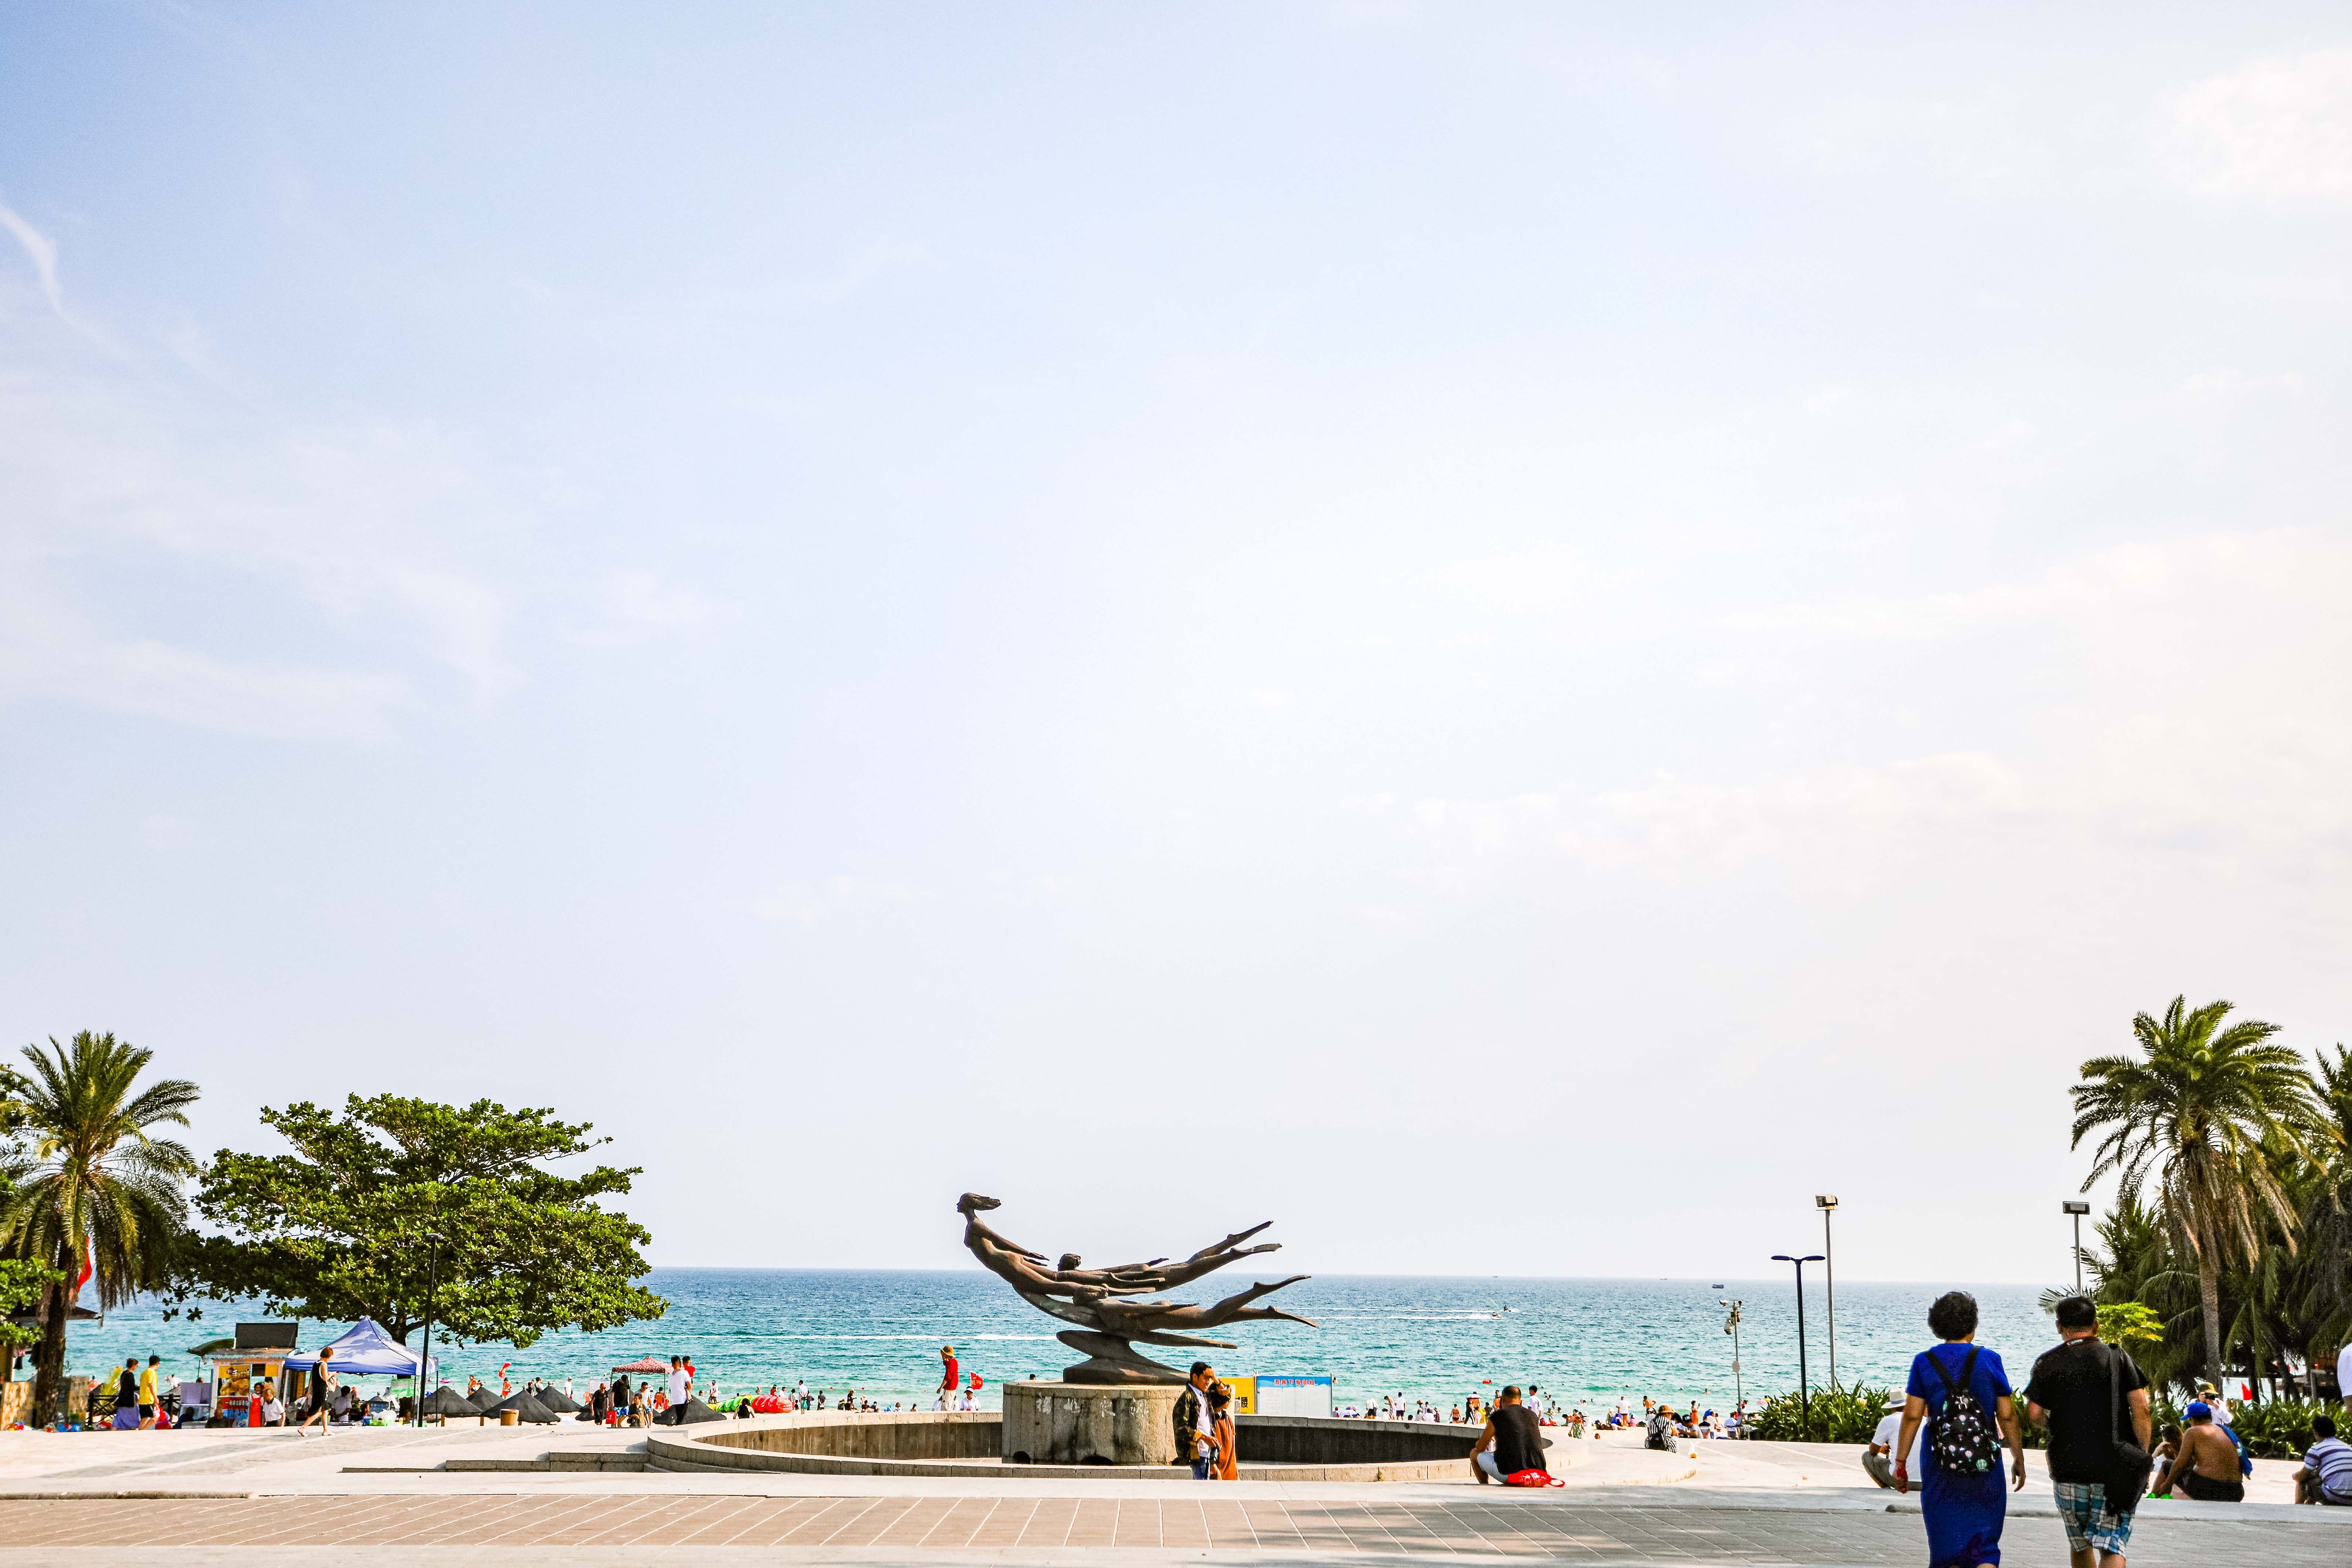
<box><xmin>19</xmin><ymin>1270</ymin><xmax>2056</xmax><ymax>1408</ymax></box>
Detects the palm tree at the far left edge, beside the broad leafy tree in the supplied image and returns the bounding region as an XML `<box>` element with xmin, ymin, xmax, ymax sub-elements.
<box><xmin>0</xmin><ymin>1030</ymin><xmax>198</xmax><ymax>1424</ymax></box>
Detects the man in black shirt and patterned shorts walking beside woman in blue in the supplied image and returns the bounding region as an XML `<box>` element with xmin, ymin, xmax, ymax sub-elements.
<box><xmin>2025</xmin><ymin>1295</ymin><xmax>2152</xmax><ymax>1568</ymax></box>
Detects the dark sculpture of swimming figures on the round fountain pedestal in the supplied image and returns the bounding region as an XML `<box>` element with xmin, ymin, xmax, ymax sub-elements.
<box><xmin>955</xmin><ymin>1192</ymin><xmax>1315</xmax><ymax>1382</ymax></box>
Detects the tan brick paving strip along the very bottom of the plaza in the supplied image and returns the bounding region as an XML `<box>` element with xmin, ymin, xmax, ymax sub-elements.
<box><xmin>0</xmin><ymin>1493</ymin><xmax>2352</xmax><ymax>1568</ymax></box>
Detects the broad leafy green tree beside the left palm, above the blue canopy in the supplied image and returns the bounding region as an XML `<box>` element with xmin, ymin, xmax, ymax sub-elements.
<box><xmin>174</xmin><ymin>1095</ymin><xmax>668</xmax><ymax>1345</ymax></box>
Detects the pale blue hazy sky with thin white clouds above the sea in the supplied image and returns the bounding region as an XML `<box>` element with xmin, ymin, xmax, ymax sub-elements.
<box><xmin>0</xmin><ymin>0</ymin><xmax>2352</xmax><ymax>1284</ymax></box>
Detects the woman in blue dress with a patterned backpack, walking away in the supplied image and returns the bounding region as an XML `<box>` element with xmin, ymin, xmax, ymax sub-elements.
<box><xmin>1896</xmin><ymin>1291</ymin><xmax>2025</xmax><ymax>1568</ymax></box>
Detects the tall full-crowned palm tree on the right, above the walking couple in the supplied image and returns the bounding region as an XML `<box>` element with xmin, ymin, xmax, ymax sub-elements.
<box><xmin>2072</xmin><ymin>997</ymin><xmax>2321</xmax><ymax>1385</ymax></box>
